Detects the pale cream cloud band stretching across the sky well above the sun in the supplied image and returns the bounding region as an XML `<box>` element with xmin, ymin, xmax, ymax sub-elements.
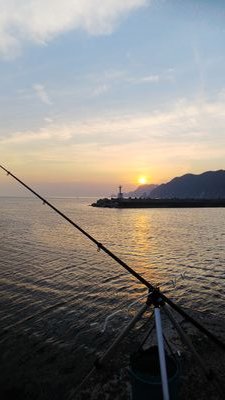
<box><xmin>0</xmin><ymin>96</ymin><xmax>225</xmax><ymax>154</ymax></box>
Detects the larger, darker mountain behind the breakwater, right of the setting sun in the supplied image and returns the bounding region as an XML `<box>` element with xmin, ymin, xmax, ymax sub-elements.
<box><xmin>146</xmin><ymin>170</ymin><xmax>225</xmax><ymax>199</ymax></box>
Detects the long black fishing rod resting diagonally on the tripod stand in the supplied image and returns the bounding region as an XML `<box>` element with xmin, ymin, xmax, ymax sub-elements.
<box><xmin>0</xmin><ymin>165</ymin><xmax>225</xmax><ymax>351</ymax></box>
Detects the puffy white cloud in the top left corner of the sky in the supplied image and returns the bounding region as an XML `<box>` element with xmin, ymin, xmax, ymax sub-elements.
<box><xmin>0</xmin><ymin>0</ymin><xmax>150</xmax><ymax>58</ymax></box>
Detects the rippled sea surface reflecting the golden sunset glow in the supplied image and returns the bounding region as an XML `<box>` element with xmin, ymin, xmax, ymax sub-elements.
<box><xmin>0</xmin><ymin>197</ymin><xmax>225</xmax><ymax>360</ymax></box>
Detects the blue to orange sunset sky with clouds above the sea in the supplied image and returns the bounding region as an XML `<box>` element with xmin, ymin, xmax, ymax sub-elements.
<box><xmin>0</xmin><ymin>0</ymin><xmax>225</xmax><ymax>196</ymax></box>
